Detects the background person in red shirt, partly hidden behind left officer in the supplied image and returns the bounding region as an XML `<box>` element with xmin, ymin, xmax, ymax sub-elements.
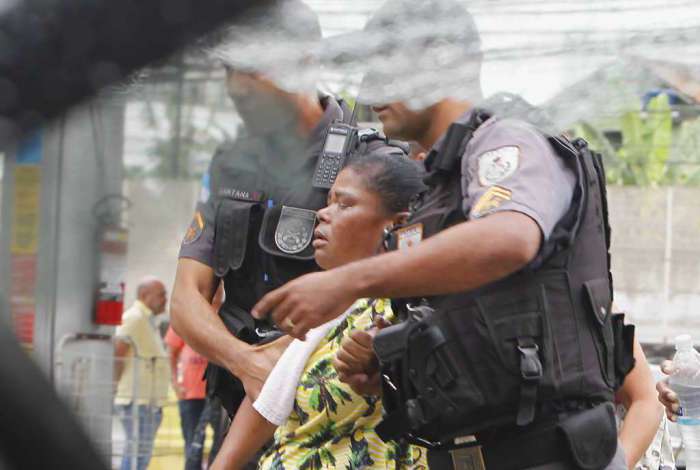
<box><xmin>165</xmin><ymin>287</ymin><xmax>223</xmax><ymax>470</ymax></box>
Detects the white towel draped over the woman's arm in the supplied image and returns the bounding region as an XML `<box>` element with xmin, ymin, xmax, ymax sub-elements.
<box><xmin>253</xmin><ymin>304</ymin><xmax>354</xmax><ymax>426</ymax></box>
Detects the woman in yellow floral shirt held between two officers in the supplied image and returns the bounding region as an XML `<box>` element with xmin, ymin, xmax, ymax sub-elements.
<box><xmin>212</xmin><ymin>153</ymin><xmax>427</xmax><ymax>470</ymax></box>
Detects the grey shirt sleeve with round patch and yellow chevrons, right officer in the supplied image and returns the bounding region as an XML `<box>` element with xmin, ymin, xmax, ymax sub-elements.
<box><xmin>434</xmin><ymin>112</ymin><xmax>576</xmax><ymax>241</ymax></box>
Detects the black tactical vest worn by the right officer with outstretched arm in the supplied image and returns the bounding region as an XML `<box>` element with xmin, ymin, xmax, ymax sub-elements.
<box><xmin>374</xmin><ymin>111</ymin><xmax>634</xmax><ymax>458</ymax></box>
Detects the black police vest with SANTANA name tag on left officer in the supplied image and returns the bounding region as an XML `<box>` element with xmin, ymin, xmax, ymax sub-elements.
<box><xmin>206</xmin><ymin>101</ymin><xmax>407</xmax><ymax>414</ymax></box>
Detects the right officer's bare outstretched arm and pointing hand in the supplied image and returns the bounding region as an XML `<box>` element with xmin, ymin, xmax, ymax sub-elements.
<box><xmin>253</xmin><ymin>211</ymin><xmax>542</xmax><ymax>339</ymax></box>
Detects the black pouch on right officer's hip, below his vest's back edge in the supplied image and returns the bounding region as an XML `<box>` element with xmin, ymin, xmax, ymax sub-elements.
<box><xmin>559</xmin><ymin>402</ymin><xmax>617</xmax><ymax>470</ymax></box>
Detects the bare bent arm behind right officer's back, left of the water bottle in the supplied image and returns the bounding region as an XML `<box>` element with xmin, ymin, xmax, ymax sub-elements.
<box><xmin>617</xmin><ymin>339</ymin><xmax>663</xmax><ymax>469</ymax></box>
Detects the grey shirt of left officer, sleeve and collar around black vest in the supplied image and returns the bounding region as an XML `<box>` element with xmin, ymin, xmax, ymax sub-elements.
<box><xmin>179</xmin><ymin>97</ymin><xmax>343</xmax><ymax>267</ymax></box>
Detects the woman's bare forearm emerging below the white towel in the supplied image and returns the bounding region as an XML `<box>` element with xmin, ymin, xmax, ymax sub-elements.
<box><xmin>210</xmin><ymin>396</ymin><xmax>277</xmax><ymax>470</ymax></box>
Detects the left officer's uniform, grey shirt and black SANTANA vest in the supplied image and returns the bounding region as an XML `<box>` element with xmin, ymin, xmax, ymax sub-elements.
<box><xmin>180</xmin><ymin>96</ymin><xmax>405</xmax><ymax>415</ymax></box>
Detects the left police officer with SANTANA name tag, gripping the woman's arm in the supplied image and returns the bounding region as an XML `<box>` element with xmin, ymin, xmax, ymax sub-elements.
<box><xmin>171</xmin><ymin>0</ymin><xmax>405</xmax><ymax>422</ymax></box>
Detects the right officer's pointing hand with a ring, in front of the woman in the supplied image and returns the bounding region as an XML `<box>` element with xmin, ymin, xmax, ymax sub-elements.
<box><xmin>251</xmin><ymin>270</ymin><xmax>356</xmax><ymax>340</ymax></box>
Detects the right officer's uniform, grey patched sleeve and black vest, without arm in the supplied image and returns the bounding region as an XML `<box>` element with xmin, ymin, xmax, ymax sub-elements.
<box><xmin>375</xmin><ymin>110</ymin><xmax>633</xmax><ymax>470</ymax></box>
